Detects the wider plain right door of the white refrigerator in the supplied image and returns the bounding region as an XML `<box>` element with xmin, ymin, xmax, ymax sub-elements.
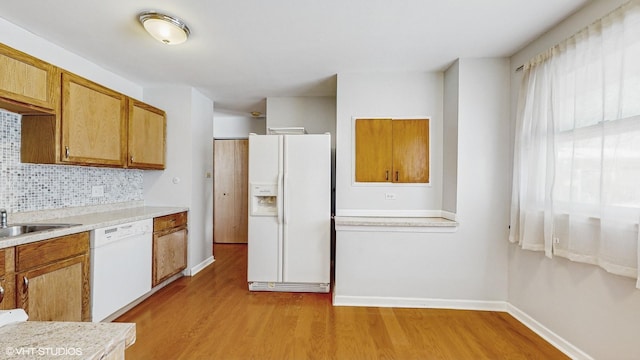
<box><xmin>283</xmin><ymin>134</ymin><xmax>331</xmax><ymax>283</ymax></box>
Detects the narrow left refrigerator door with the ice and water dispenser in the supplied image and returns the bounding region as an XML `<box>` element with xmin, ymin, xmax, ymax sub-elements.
<box><xmin>247</xmin><ymin>135</ymin><xmax>283</xmax><ymax>282</ymax></box>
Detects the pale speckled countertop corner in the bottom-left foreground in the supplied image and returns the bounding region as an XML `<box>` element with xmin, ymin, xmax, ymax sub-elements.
<box><xmin>0</xmin><ymin>321</ymin><xmax>136</xmax><ymax>360</ymax></box>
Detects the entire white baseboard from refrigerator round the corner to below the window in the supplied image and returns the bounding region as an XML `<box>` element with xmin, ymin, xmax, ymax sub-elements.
<box><xmin>333</xmin><ymin>292</ymin><xmax>593</xmax><ymax>360</ymax></box>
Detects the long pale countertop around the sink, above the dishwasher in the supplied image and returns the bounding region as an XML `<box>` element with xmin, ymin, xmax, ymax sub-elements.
<box><xmin>0</xmin><ymin>206</ymin><xmax>188</xmax><ymax>249</ymax></box>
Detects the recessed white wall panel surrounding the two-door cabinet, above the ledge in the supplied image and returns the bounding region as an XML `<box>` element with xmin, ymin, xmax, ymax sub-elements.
<box><xmin>336</xmin><ymin>72</ymin><xmax>443</xmax><ymax>216</ymax></box>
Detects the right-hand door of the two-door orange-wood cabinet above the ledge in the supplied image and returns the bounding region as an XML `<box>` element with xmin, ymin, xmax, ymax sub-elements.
<box><xmin>393</xmin><ymin>119</ymin><xmax>429</xmax><ymax>183</ymax></box>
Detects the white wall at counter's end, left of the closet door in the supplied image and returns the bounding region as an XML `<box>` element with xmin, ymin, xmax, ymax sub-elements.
<box><xmin>144</xmin><ymin>86</ymin><xmax>213</xmax><ymax>268</ymax></box>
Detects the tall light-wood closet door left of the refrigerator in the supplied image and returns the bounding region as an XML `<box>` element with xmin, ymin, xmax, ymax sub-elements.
<box><xmin>213</xmin><ymin>140</ymin><xmax>249</xmax><ymax>243</ymax></box>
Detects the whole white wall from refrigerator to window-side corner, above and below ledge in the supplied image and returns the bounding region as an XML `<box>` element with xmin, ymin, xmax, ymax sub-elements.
<box><xmin>334</xmin><ymin>59</ymin><xmax>510</xmax><ymax>307</ymax></box>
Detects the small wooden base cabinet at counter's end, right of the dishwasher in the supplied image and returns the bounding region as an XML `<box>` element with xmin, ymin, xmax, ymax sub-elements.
<box><xmin>151</xmin><ymin>212</ymin><xmax>188</xmax><ymax>286</ymax></box>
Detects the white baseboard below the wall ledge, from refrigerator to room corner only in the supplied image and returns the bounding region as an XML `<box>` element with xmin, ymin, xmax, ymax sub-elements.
<box><xmin>333</xmin><ymin>293</ymin><xmax>508</xmax><ymax>312</ymax></box>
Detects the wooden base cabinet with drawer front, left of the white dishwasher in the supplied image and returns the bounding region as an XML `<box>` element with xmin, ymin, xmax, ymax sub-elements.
<box><xmin>15</xmin><ymin>232</ymin><xmax>91</xmax><ymax>321</ymax></box>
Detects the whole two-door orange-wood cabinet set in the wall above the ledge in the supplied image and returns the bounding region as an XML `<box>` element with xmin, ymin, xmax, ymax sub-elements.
<box><xmin>355</xmin><ymin>119</ymin><xmax>429</xmax><ymax>183</ymax></box>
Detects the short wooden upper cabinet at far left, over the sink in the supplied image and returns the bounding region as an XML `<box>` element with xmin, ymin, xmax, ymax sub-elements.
<box><xmin>0</xmin><ymin>44</ymin><xmax>60</xmax><ymax>114</ymax></box>
